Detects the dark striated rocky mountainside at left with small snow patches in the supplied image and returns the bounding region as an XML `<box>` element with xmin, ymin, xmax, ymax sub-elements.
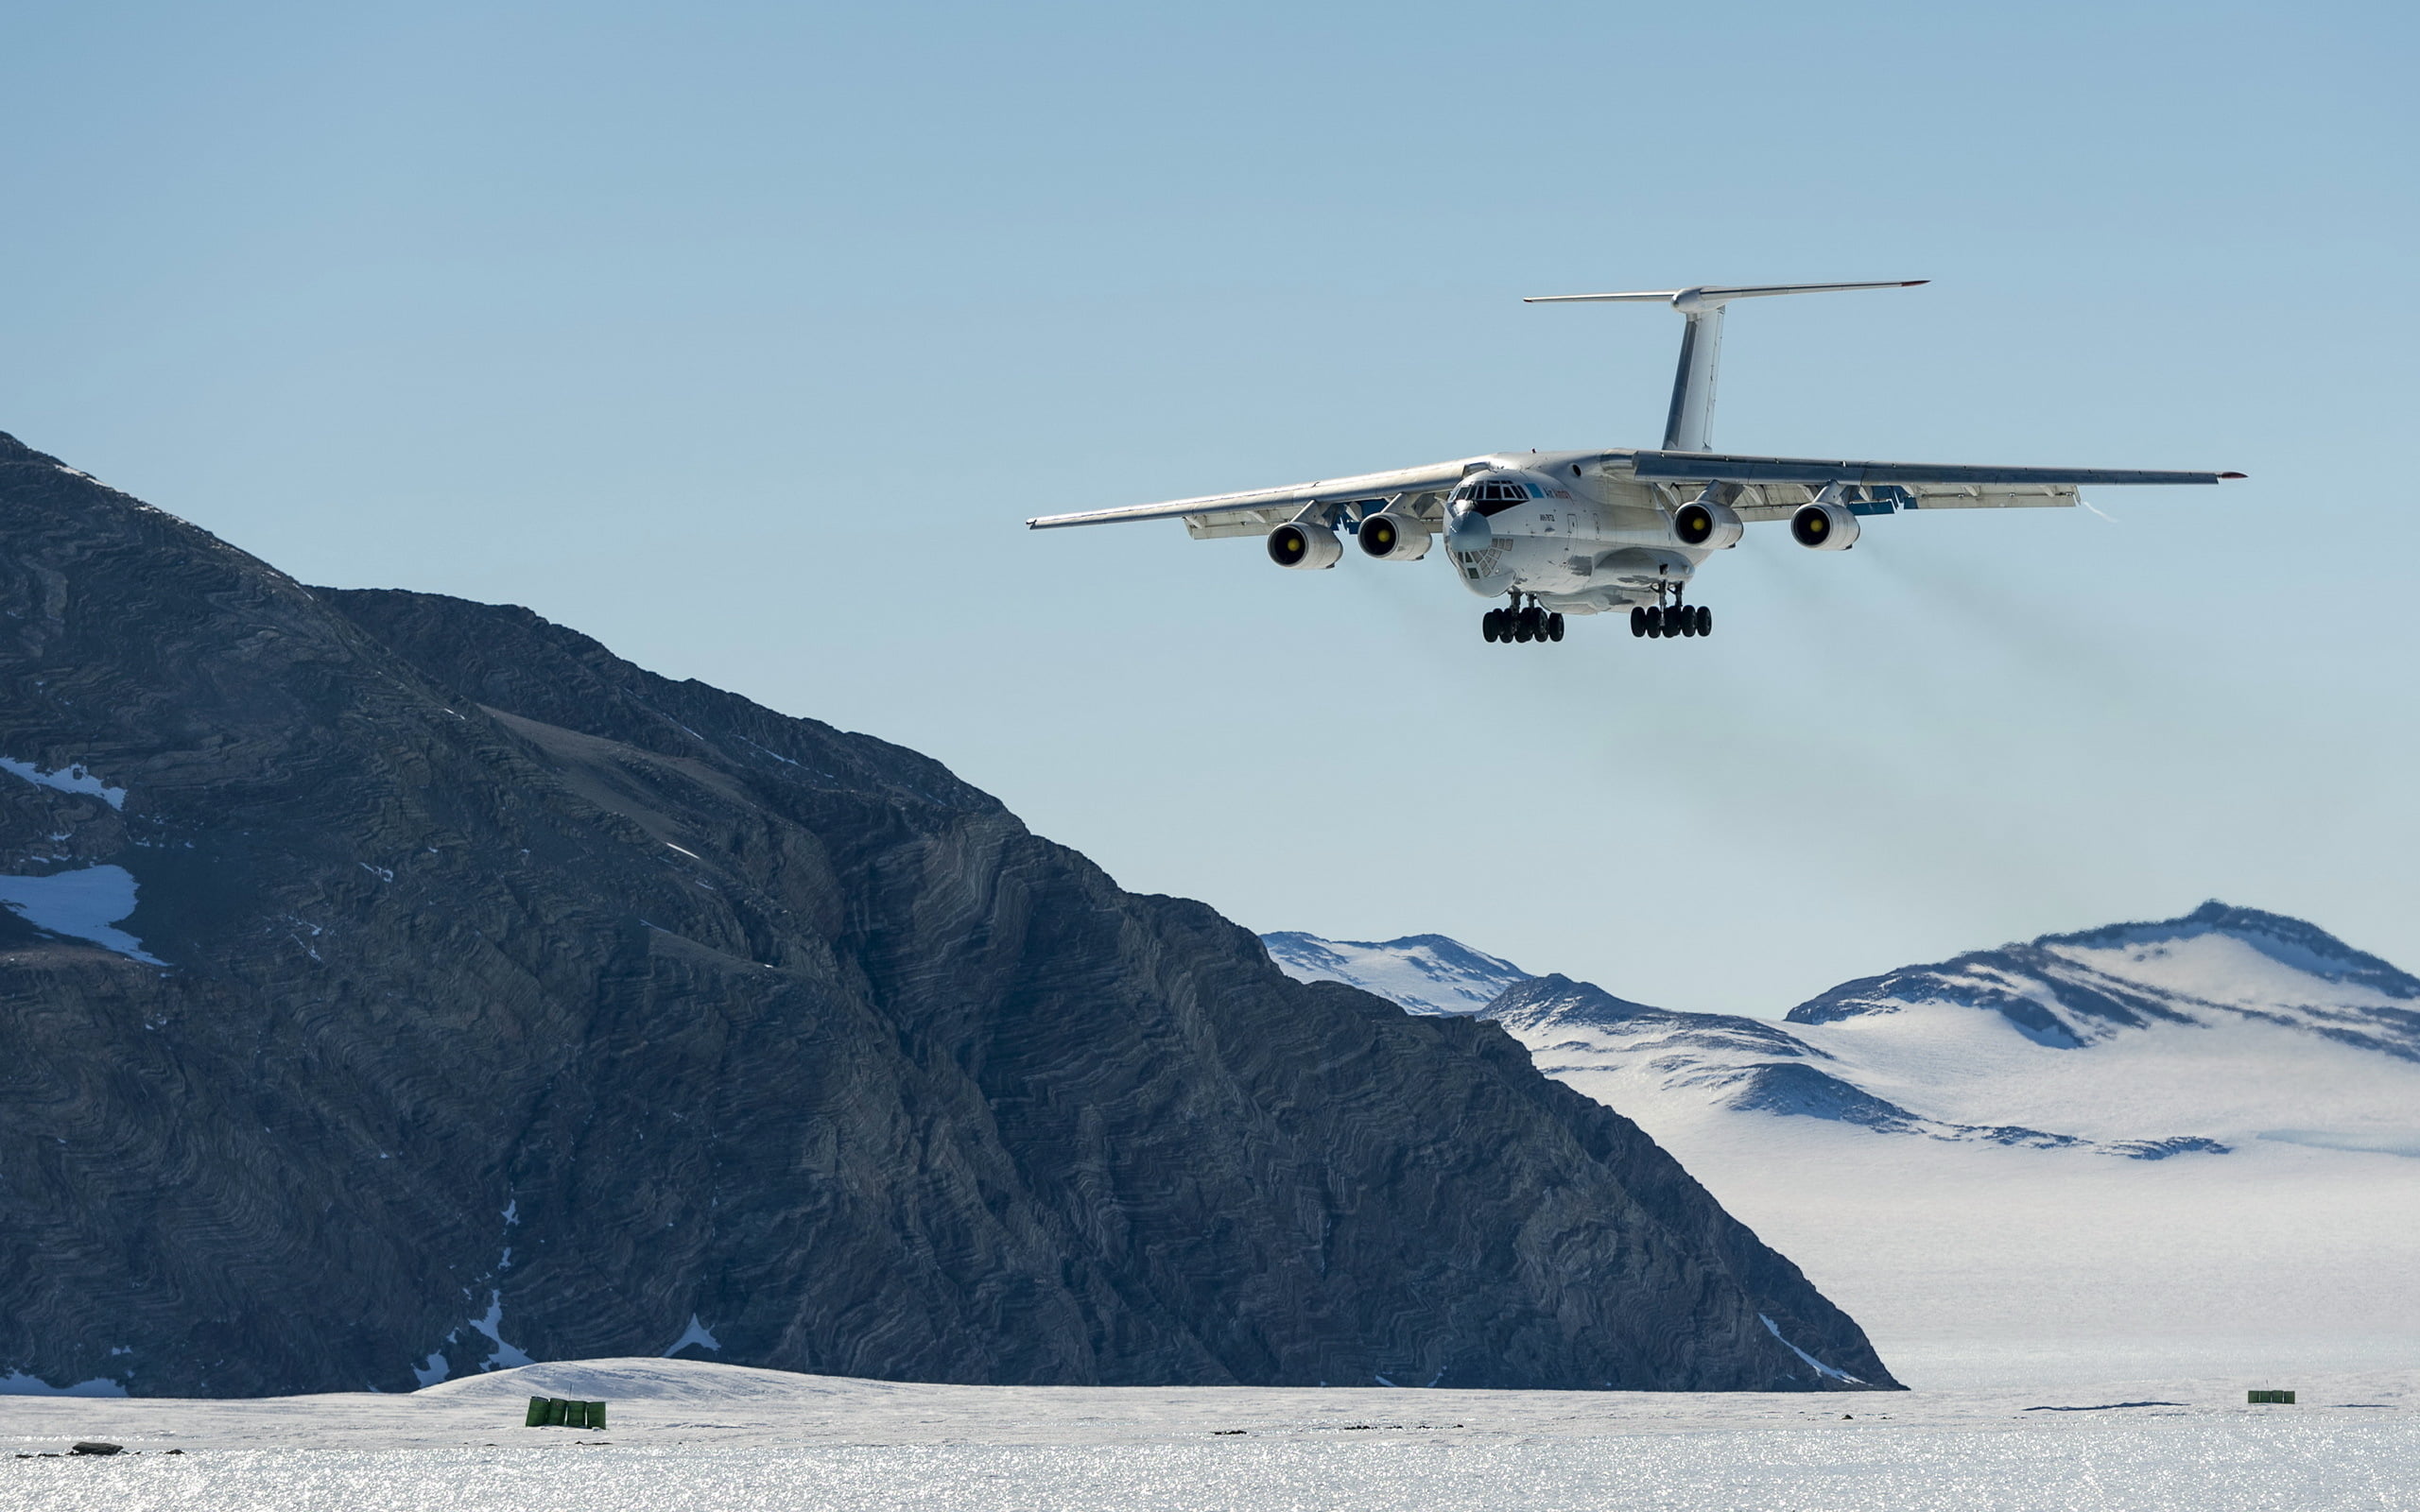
<box><xmin>0</xmin><ymin>425</ymin><xmax>1893</xmax><ymax>1394</ymax></box>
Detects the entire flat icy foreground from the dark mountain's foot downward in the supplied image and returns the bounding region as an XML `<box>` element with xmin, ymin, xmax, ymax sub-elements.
<box><xmin>0</xmin><ymin>1360</ymin><xmax>2420</xmax><ymax>1512</ymax></box>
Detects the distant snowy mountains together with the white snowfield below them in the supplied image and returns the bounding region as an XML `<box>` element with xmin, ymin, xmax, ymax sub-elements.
<box><xmin>1268</xmin><ymin>902</ymin><xmax>2420</xmax><ymax>1383</ymax></box>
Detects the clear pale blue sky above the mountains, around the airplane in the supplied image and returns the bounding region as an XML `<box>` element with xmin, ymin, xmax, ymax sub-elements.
<box><xmin>0</xmin><ymin>0</ymin><xmax>2420</xmax><ymax>1011</ymax></box>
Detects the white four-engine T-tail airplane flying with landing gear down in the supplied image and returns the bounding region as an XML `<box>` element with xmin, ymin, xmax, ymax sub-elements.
<box><xmin>1026</xmin><ymin>278</ymin><xmax>2243</xmax><ymax>641</ymax></box>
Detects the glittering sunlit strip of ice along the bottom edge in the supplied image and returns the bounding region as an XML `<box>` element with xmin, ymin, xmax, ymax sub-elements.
<box><xmin>0</xmin><ymin>1422</ymin><xmax>2420</xmax><ymax>1512</ymax></box>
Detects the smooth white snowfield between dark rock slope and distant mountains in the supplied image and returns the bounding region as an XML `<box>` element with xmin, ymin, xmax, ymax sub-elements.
<box><xmin>1537</xmin><ymin>1025</ymin><xmax>2420</xmax><ymax>1388</ymax></box>
